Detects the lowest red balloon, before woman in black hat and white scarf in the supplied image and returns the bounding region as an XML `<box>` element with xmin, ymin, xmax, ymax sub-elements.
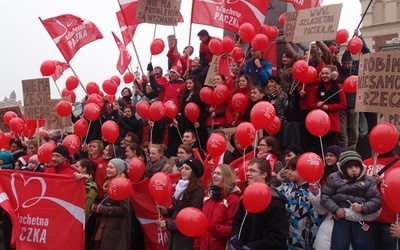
<box><xmin>175</xmin><ymin>207</ymin><xmax>209</xmax><ymax>237</ymax></box>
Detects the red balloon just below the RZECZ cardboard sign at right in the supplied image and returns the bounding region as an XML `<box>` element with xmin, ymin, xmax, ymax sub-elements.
<box><xmin>368</xmin><ymin>123</ymin><xmax>399</xmax><ymax>154</ymax></box>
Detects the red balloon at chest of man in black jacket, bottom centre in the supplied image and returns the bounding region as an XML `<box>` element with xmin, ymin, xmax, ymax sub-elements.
<box><xmin>242</xmin><ymin>182</ymin><xmax>272</xmax><ymax>214</ymax></box>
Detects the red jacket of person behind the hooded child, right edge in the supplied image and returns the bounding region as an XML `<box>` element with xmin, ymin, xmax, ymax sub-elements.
<box><xmin>363</xmin><ymin>154</ymin><xmax>400</xmax><ymax>223</ymax></box>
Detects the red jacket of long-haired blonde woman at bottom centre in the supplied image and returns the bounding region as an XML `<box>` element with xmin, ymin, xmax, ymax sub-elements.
<box><xmin>194</xmin><ymin>193</ymin><xmax>239</xmax><ymax>250</ymax></box>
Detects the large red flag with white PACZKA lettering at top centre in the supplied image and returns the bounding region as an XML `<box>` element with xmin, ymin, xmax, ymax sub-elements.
<box><xmin>192</xmin><ymin>0</ymin><xmax>270</xmax><ymax>32</ymax></box>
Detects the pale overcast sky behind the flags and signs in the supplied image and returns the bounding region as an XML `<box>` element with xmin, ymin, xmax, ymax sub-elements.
<box><xmin>0</xmin><ymin>0</ymin><xmax>361</xmax><ymax>101</ymax></box>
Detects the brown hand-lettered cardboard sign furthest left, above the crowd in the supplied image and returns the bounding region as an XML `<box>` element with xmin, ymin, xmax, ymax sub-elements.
<box><xmin>22</xmin><ymin>78</ymin><xmax>51</xmax><ymax>120</ymax></box>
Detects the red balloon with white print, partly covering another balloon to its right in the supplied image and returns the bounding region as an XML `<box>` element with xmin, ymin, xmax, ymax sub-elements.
<box><xmin>250</xmin><ymin>101</ymin><xmax>275</xmax><ymax>129</ymax></box>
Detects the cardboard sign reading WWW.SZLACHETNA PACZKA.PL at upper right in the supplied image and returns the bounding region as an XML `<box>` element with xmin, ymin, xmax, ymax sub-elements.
<box><xmin>285</xmin><ymin>4</ymin><xmax>342</xmax><ymax>43</ymax></box>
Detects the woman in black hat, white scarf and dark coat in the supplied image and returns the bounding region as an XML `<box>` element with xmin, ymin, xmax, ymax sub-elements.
<box><xmin>158</xmin><ymin>157</ymin><xmax>204</xmax><ymax>250</ymax></box>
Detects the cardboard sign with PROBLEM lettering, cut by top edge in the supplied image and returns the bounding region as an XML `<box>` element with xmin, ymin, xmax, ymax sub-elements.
<box><xmin>136</xmin><ymin>0</ymin><xmax>181</xmax><ymax>26</ymax></box>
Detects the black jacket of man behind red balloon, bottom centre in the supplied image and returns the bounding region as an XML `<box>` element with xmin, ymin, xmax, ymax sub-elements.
<box><xmin>232</xmin><ymin>187</ymin><xmax>289</xmax><ymax>250</ymax></box>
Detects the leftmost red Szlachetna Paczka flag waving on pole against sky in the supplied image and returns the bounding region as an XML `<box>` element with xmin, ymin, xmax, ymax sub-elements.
<box><xmin>40</xmin><ymin>14</ymin><xmax>103</xmax><ymax>62</ymax></box>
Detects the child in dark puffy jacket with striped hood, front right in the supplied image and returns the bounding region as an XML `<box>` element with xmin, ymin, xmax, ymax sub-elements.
<box><xmin>321</xmin><ymin>151</ymin><xmax>382</xmax><ymax>250</ymax></box>
